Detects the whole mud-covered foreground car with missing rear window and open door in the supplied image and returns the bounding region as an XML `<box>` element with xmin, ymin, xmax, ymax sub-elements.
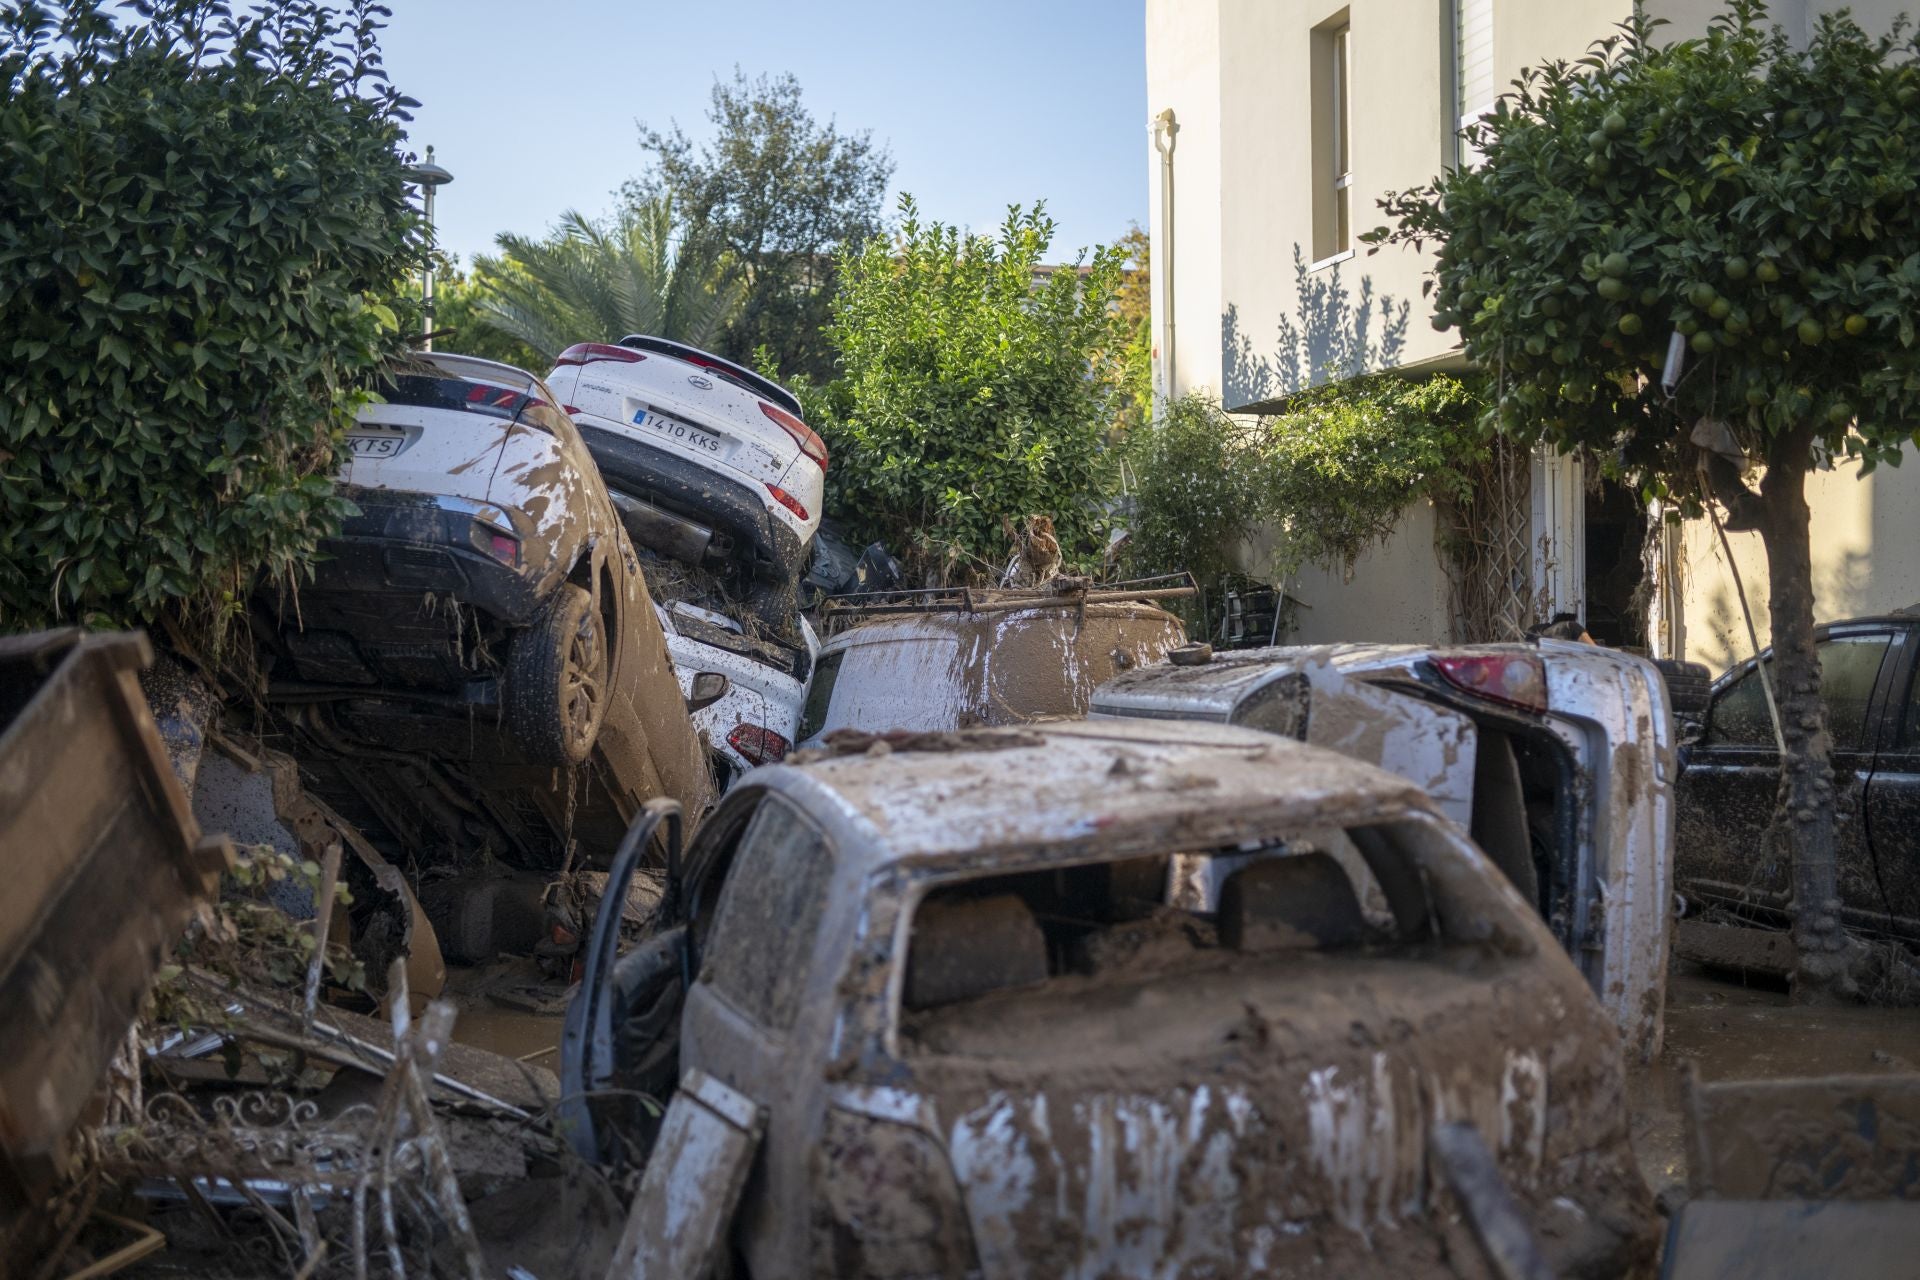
<box><xmin>563</xmin><ymin>722</ymin><xmax>1651</xmax><ymax>1278</ymax></box>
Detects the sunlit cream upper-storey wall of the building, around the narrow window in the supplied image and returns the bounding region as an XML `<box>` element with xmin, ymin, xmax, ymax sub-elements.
<box><xmin>1146</xmin><ymin>0</ymin><xmax>1626</xmax><ymax>409</ymax></box>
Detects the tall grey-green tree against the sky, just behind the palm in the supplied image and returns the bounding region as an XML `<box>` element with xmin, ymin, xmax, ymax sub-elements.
<box><xmin>626</xmin><ymin>69</ymin><xmax>893</xmax><ymax>380</ymax></box>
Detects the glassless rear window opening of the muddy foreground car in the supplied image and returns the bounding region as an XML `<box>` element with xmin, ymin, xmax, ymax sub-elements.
<box><xmin>900</xmin><ymin>821</ymin><xmax>1482</xmax><ymax>1052</ymax></box>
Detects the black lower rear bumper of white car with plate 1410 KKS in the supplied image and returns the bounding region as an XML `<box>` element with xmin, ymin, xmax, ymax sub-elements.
<box><xmin>576</xmin><ymin>415</ymin><xmax>806</xmax><ymax>578</ymax></box>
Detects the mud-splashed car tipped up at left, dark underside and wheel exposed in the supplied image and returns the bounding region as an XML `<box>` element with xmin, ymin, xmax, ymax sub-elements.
<box><xmin>255</xmin><ymin>353</ymin><xmax>710</xmax><ymax>864</ymax></box>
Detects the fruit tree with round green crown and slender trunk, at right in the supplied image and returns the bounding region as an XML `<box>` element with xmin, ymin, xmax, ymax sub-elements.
<box><xmin>1375</xmin><ymin>0</ymin><xmax>1920</xmax><ymax>994</ymax></box>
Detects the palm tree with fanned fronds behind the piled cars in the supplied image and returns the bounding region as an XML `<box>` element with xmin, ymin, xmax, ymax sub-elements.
<box><xmin>474</xmin><ymin>196</ymin><xmax>745</xmax><ymax>359</ymax></box>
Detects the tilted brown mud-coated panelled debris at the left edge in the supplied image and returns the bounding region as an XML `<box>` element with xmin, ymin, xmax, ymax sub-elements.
<box><xmin>0</xmin><ymin>629</ymin><xmax>232</xmax><ymax>1228</ymax></box>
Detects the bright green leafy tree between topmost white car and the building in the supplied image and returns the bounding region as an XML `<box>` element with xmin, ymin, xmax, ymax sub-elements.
<box><xmin>808</xmin><ymin>196</ymin><xmax>1121</xmax><ymax>568</ymax></box>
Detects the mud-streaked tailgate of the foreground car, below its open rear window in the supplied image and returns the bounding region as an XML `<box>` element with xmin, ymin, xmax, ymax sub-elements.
<box><xmin>902</xmin><ymin>946</ymin><xmax>1638</xmax><ymax>1276</ymax></box>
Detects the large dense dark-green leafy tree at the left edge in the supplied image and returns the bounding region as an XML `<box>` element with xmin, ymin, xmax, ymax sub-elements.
<box><xmin>0</xmin><ymin>0</ymin><xmax>424</xmax><ymax>639</ymax></box>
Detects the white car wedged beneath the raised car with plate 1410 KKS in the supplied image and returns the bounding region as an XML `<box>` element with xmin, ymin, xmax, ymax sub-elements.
<box><xmin>657</xmin><ymin>601</ymin><xmax>820</xmax><ymax>791</ymax></box>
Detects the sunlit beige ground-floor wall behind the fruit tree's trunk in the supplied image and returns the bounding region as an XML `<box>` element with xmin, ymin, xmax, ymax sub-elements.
<box><xmin>1680</xmin><ymin>445</ymin><xmax>1920</xmax><ymax>672</ymax></box>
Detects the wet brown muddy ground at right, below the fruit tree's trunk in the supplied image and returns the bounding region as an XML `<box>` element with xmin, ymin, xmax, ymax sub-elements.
<box><xmin>1626</xmin><ymin>961</ymin><xmax>1920</xmax><ymax>1203</ymax></box>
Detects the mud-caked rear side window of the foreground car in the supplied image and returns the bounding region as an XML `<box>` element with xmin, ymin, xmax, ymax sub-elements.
<box><xmin>705</xmin><ymin>796</ymin><xmax>833</xmax><ymax>1031</ymax></box>
